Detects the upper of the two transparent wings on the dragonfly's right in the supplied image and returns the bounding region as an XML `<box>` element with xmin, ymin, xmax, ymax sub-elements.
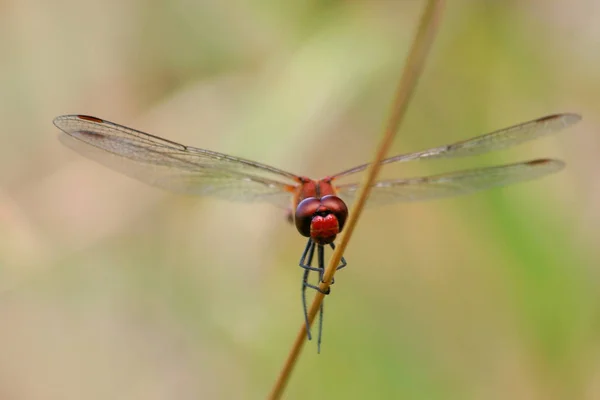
<box><xmin>332</xmin><ymin>113</ymin><xmax>581</xmax><ymax>178</ymax></box>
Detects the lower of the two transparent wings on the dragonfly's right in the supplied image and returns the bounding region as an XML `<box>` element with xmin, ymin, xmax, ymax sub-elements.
<box><xmin>337</xmin><ymin>159</ymin><xmax>564</xmax><ymax>206</ymax></box>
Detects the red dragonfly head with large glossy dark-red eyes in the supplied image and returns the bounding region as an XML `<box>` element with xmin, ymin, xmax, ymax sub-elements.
<box><xmin>294</xmin><ymin>195</ymin><xmax>348</xmax><ymax>244</ymax></box>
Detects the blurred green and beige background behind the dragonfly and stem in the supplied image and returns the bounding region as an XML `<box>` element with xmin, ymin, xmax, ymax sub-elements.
<box><xmin>0</xmin><ymin>0</ymin><xmax>600</xmax><ymax>400</ymax></box>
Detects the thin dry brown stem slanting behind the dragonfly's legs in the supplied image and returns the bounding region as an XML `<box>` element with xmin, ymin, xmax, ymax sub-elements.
<box><xmin>268</xmin><ymin>0</ymin><xmax>444</xmax><ymax>399</ymax></box>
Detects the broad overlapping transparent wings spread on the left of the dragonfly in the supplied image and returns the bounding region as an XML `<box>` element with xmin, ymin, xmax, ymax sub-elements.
<box><xmin>54</xmin><ymin>115</ymin><xmax>296</xmax><ymax>208</ymax></box>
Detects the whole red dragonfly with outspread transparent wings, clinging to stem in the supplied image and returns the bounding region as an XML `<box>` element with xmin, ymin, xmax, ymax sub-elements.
<box><xmin>54</xmin><ymin>113</ymin><xmax>581</xmax><ymax>351</ymax></box>
